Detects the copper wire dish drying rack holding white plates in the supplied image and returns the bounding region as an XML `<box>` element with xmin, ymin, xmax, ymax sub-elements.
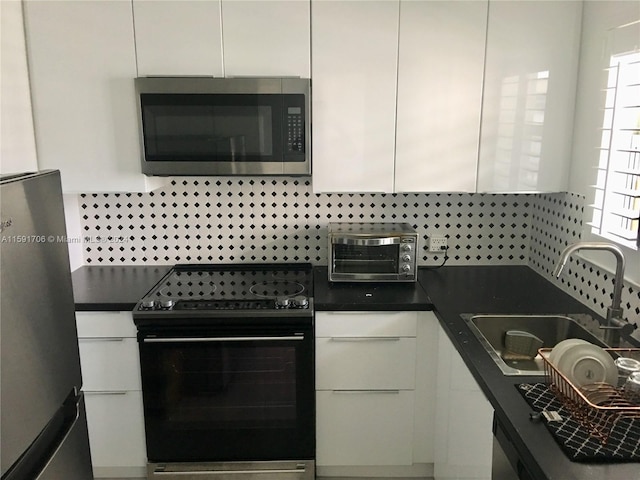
<box><xmin>538</xmin><ymin>348</ymin><xmax>640</xmax><ymax>444</ymax></box>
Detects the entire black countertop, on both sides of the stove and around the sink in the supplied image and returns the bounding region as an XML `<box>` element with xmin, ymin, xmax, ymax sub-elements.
<box><xmin>72</xmin><ymin>266</ymin><xmax>640</xmax><ymax>480</ymax></box>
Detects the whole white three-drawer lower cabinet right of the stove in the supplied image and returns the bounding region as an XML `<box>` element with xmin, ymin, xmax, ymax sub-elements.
<box><xmin>316</xmin><ymin>312</ymin><xmax>437</xmax><ymax>478</ymax></box>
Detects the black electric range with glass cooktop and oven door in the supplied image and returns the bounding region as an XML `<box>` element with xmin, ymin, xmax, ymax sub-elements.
<box><xmin>133</xmin><ymin>264</ymin><xmax>315</xmax><ymax>480</ymax></box>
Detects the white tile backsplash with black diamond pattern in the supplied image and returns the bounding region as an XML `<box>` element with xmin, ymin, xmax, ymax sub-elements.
<box><xmin>79</xmin><ymin>177</ymin><xmax>640</xmax><ymax>320</ymax></box>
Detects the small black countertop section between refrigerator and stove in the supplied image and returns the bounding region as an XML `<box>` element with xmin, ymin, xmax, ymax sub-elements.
<box><xmin>71</xmin><ymin>266</ymin><xmax>171</xmax><ymax>311</ymax></box>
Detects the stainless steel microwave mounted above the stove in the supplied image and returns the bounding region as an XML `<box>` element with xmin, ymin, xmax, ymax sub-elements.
<box><xmin>135</xmin><ymin>77</ymin><xmax>311</xmax><ymax>175</ymax></box>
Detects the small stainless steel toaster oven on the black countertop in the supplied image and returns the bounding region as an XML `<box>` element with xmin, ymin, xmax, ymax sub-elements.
<box><xmin>328</xmin><ymin>223</ymin><xmax>418</xmax><ymax>282</ymax></box>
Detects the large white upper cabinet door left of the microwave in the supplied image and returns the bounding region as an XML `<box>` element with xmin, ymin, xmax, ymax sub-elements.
<box><xmin>24</xmin><ymin>1</ymin><xmax>164</xmax><ymax>193</ymax></box>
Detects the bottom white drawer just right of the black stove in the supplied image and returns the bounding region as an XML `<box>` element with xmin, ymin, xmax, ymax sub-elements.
<box><xmin>316</xmin><ymin>391</ymin><xmax>414</xmax><ymax>466</ymax></box>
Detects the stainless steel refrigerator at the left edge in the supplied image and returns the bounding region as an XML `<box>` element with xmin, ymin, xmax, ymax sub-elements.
<box><xmin>0</xmin><ymin>170</ymin><xmax>93</xmax><ymax>480</ymax></box>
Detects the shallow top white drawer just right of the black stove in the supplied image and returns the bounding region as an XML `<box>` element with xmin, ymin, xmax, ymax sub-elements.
<box><xmin>316</xmin><ymin>312</ymin><xmax>419</xmax><ymax>337</ymax></box>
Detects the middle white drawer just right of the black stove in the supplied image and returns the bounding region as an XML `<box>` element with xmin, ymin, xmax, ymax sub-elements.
<box><xmin>316</xmin><ymin>336</ymin><xmax>416</xmax><ymax>390</ymax></box>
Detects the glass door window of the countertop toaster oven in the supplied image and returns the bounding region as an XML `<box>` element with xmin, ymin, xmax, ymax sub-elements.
<box><xmin>333</xmin><ymin>244</ymin><xmax>399</xmax><ymax>274</ymax></box>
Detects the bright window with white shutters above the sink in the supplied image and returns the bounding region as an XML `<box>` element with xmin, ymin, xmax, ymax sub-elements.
<box><xmin>590</xmin><ymin>43</ymin><xmax>640</xmax><ymax>250</ymax></box>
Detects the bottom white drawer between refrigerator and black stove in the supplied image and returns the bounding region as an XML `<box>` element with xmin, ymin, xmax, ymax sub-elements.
<box><xmin>85</xmin><ymin>392</ymin><xmax>147</xmax><ymax>468</ymax></box>
